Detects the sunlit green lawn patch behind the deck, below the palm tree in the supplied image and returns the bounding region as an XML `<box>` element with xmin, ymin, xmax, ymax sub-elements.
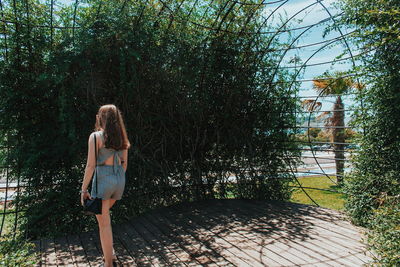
<box><xmin>290</xmin><ymin>176</ymin><xmax>346</xmax><ymax>213</ymax></box>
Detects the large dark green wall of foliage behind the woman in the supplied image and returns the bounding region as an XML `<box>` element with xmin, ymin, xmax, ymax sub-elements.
<box><xmin>0</xmin><ymin>0</ymin><xmax>299</xmax><ymax>237</ymax></box>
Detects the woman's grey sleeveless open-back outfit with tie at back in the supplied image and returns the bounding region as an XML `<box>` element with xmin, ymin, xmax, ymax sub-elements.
<box><xmin>91</xmin><ymin>131</ymin><xmax>125</xmax><ymax>200</ymax></box>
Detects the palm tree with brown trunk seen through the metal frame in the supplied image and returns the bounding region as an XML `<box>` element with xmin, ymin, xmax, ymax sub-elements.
<box><xmin>302</xmin><ymin>72</ymin><xmax>362</xmax><ymax>185</ymax></box>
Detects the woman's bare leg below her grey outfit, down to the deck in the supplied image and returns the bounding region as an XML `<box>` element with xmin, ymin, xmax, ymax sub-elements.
<box><xmin>96</xmin><ymin>199</ymin><xmax>113</xmax><ymax>267</ymax></box>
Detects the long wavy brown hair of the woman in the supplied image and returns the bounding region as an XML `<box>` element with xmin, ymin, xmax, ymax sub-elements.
<box><xmin>95</xmin><ymin>104</ymin><xmax>131</xmax><ymax>150</ymax></box>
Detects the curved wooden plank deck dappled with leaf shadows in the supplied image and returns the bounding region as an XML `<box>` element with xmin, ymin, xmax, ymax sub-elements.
<box><xmin>32</xmin><ymin>200</ymin><xmax>371</xmax><ymax>266</ymax></box>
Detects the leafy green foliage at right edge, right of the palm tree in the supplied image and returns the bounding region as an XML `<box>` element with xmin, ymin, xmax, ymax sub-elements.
<box><xmin>340</xmin><ymin>0</ymin><xmax>400</xmax><ymax>266</ymax></box>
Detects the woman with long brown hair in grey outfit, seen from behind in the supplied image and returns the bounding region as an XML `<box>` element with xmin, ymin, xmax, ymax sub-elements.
<box><xmin>81</xmin><ymin>105</ymin><xmax>130</xmax><ymax>267</ymax></box>
